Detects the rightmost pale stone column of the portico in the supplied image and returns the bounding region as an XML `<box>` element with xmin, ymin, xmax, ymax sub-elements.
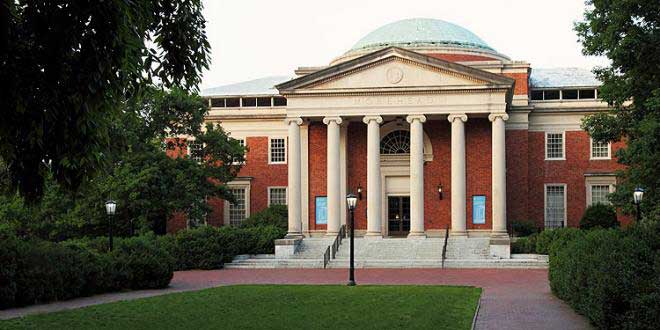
<box><xmin>488</xmin><ymin>113</ymin><xmax>509</xmax><ymax>237</ymax></box>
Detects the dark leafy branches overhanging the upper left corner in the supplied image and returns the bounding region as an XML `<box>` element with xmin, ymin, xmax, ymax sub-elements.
<box><xmin>0</xmin><ymin>0</ymin><xmax>209</xmax><ymax>201</ymax></box>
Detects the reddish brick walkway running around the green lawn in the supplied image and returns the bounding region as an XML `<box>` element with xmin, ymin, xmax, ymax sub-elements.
<box><xmin>0</xmin><ymin>269</ymin><xmax>590</xmax><ymax>329</ymax></box>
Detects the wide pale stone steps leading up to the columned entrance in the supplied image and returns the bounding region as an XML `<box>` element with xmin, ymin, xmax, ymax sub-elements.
<box><xmin>225</xmin><ymin>237</ymin><xmax>548</xmax><ymax>268</ymax></box>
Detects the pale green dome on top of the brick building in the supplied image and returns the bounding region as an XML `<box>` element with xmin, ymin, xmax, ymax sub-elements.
<box><xmin>351</xmin><ymin>18</ymin><xmax>495</xmax><ymax>52</ymax></box>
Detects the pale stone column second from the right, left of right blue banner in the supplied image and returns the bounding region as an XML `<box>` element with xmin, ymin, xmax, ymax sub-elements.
<box><xmin>447</xmin><ymin>114</ymin><xmax>467</xmax><ymax>236</ymax></box>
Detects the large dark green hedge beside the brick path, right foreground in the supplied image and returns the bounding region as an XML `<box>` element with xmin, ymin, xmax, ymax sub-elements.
<box><xmin>549</xmin><ymin>221</ymin><xmax>660</xmax><ymax>329</ymax></box>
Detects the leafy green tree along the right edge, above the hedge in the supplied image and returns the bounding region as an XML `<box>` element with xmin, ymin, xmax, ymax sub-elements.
<box><xmin>575</xmin><ymin>0</ymin><xmax>660</xmax><ymax>219</ymax></box>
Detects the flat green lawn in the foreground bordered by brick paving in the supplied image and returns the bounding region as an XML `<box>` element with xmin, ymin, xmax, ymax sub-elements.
<box><xmin>0</xmin><ymin>285</ymin><xmax>481</xmax><ymax>330</ymax></box>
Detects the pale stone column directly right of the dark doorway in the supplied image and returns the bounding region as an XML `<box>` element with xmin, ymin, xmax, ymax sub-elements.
<box><xmin>406</xmin><ymin>115</ymin><xmax>426</xmax><ymax>237</ymax></box>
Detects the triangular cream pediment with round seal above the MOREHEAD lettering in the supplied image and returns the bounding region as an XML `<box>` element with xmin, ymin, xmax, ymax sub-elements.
<box><xmin>276</xmin><ymin>47</ymin><xmax>514</xmax><ymax>94</ymax></box>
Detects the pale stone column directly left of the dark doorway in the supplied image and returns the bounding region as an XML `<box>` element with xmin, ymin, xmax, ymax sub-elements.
<box><xmin>362</xmin><ymin>116</ymin><xmax>383</xmax><ymax>237</ymax></box>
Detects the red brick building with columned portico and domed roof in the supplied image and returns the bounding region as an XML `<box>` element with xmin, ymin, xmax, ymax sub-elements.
<box><xmin>172</xmin><ymin>19</ymin><xmax>621</xmax><ymax>258</ymax></box>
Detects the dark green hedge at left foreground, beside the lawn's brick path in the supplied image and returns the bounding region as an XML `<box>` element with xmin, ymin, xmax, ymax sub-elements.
<box><xmin>0</xmin><ymin>236</ymin><xmax>174</xmax><ymax>308</ymax></box>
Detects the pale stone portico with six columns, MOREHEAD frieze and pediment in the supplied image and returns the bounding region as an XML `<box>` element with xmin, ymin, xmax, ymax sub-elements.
<box><xmin>277</xmin><ymin>47</ymin><xmax>514</xmax><ymax>245</ymax></box>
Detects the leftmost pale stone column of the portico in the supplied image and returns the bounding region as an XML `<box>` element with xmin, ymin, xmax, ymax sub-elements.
<box><xmin>285</xmin><ymin>117</ymin><xmax>302</xmax><ymax>238</ymax></box>
